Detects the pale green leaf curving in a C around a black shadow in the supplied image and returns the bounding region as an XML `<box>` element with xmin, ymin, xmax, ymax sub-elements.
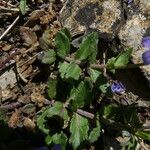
<box><xmin>37</xmin><ymin>102</ymin><xmax>69</xmax><ymax>134</ymax></box>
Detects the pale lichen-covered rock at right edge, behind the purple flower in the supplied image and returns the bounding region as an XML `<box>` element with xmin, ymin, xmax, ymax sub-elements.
<box><xmin>118</xmin><ymin>0</ymin><xmax>150</xmax><ymax>83</ymax></box>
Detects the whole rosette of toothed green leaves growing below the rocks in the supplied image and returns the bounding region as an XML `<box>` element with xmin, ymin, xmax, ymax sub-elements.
<box><xmin>37</xmin><ymin>29</ymin><xmax>148</xmax><ymax>150</ymax></box>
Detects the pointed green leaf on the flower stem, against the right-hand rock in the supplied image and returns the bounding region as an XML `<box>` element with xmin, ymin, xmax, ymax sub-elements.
<box><xmin>114</xmin><ymin>48</ymin><xmax>133</xmax><ymax>68</ymax></box>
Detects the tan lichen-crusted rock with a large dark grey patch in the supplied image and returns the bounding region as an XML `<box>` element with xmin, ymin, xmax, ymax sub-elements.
<box><xmin>60</xmin><ymin>0</ymin><xmax>124</xmax><ymax>38</ymax></box>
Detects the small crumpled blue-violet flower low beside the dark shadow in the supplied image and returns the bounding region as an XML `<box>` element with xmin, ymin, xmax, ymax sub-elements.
<box><xmin>111</xmin><ymin>81</ymin><xmax>125</xmax><ymax>94</ymax></box>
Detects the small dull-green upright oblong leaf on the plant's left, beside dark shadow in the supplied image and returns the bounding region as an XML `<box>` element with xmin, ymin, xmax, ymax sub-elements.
<box><xmin>47</xmin><ymin>78</ymin><xmax>57</xmax><ymax>99</ymax></box>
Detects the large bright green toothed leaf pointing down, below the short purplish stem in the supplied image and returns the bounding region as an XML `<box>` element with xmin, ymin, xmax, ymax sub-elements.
<box><xmin>69</xmin><ymin>113</ymin><xmax>89</xmax><ymax>150</ymax></box>
